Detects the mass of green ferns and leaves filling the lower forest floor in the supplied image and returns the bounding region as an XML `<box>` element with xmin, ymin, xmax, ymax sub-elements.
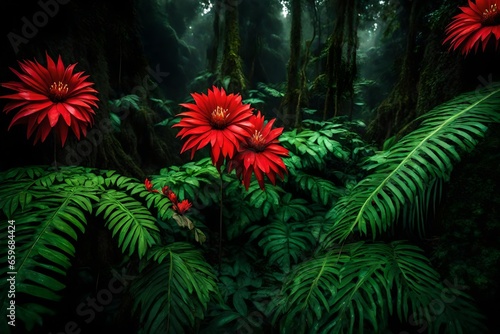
<box><xmin>0</xmin><ymin>85</ymin><xmax>500</xmax><ymax>333</ymax></box>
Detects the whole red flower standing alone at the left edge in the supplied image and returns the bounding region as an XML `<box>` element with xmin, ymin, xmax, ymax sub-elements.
<box><xmin>0</xmin><ymin>54</ymin><xmax>99</xmax><ymax>146</ymax></box>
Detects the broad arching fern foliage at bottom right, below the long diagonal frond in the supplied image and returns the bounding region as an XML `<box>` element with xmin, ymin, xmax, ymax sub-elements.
<box><xmin>273</xmin><ymin>241</ymin><xmax>482</xmax><ymax>333</ymax></box>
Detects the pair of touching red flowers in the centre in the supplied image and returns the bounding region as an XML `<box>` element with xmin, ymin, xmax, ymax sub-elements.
<box><xmin>174</xmin><ymin>86</ymin><xmax>288</xmax><ymax>190</ymax></box>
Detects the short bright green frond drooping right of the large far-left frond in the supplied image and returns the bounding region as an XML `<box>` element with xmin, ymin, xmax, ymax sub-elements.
<box><xmin>96</xmin><ymin>190</ymin><xmax>159</xmax><ymax>258</ymax></box>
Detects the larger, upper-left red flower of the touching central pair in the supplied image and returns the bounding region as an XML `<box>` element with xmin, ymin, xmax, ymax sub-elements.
<box><xmin>174</xmin><ymin>86</ymin><xmax>252</xmax><ymax>169</ymax></box>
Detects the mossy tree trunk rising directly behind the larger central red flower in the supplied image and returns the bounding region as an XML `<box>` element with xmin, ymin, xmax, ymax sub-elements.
<box><xmin>219</xmin><ymin>6</ymin><xmax>246</xmax><ymax>92</ymax></box>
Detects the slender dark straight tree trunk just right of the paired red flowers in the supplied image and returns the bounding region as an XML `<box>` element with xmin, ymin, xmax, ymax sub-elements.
<box><xmin>281</xmin><ymin>0</ymin><xmax>303</xmax><ymax>127</ymax></box>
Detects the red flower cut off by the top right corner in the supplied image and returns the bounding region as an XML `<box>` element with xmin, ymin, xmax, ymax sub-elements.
<box><xmin>443</xmin><ymin>0</ymin><xmax>500</xmax><ymax>55</ymax></box>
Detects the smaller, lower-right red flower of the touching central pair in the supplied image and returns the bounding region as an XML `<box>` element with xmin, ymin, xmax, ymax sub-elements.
<box><xmin>228</xmin><ymin>111</ymin><xmax>288</xmax><ymax>190</ymax></box>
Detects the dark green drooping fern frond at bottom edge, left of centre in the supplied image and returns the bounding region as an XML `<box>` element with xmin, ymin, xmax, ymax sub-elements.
<box><xmin>131</xmin><ymin>242</ymin><xmax>220</xmax><ymax>333</ymax></box>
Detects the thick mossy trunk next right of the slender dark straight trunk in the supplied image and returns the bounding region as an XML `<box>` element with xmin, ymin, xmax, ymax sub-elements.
<box><xmin>323</xmin><ymin>0</ymin><xmax>358</xmax><ymax>120</ymax></box>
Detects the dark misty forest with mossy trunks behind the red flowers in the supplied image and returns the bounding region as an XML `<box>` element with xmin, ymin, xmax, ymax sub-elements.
<box><xmin>0</xmin><ymin>0</ymin><xmax>499</xmax><ymax>176</ymax></box>
